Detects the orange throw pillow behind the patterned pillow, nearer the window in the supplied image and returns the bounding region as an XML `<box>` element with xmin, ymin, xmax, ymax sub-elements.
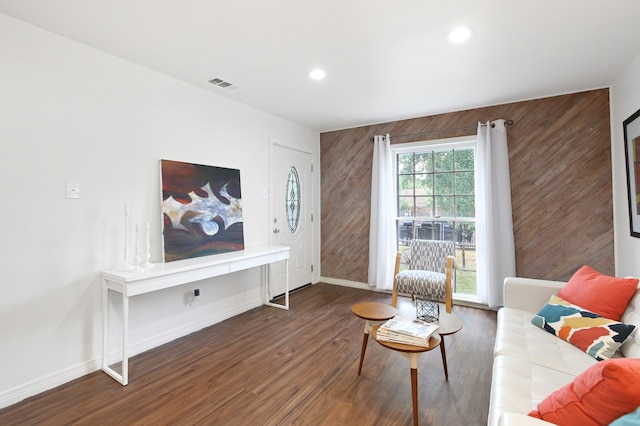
<box><xmin>558</xmin><ymin>265</ymin><xmax>638</xmax><ymax>321</ymax></box>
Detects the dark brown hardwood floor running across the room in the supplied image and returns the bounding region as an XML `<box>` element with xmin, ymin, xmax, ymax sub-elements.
<box><xmin>0</xmin><ymin>283</ymin><xmax>496</xmax><ymax>425</ymax></box>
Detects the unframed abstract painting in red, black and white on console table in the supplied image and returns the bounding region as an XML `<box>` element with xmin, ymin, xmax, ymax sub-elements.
<box><xmin>160</xmin><ymin>160</ymin><xmax>244</xmax><ymax>262</ymax></box>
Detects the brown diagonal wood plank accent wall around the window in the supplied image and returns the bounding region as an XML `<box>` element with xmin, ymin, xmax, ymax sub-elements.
<box><xmin>320</xmin><ymin>89</ymin><xmax>614</xmax><ymax>283</ymax></box>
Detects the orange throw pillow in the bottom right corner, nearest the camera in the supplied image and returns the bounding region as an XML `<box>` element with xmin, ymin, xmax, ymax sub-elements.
<box><xmin>529</xmin><ymin>358</ymin><xmax>640</xmax><ymax>425</ymax></box>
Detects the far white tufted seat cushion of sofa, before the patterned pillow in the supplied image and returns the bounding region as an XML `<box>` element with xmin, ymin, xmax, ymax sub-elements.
<box><xmin>494</xmin><ymin>308</ymin><xmax>598</xmax><ymax>374</ymax></box>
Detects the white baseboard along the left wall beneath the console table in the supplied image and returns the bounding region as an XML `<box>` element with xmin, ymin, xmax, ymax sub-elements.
<box><xmin>0</xmin><ymin>299</ymin><xmax>263</xmax><ymax>408</ymax></box>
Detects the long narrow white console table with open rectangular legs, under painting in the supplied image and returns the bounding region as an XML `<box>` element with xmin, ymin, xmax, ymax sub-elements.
<box><xmin>101</xmin><ymin>246</ymin><xmax>289</xmax><ymax>386</ymax></box>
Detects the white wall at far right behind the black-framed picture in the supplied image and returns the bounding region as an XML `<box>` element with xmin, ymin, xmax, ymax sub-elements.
<box><xmin>610</xmin><ymin>51</ymin><xmax>640</xmax><ymax>277</ymax></box>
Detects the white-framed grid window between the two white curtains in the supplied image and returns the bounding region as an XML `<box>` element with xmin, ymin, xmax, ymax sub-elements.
<box><xmin>392</xmin><ymin>138</ymin><xmax>477</xmax><ymax>299</ymax></box>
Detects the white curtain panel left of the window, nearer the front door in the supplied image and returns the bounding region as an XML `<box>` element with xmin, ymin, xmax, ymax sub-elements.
<box><xmin>368</xmin><ymin>135</ymin><xmax>396</xmax><ymax>290</ymax></box>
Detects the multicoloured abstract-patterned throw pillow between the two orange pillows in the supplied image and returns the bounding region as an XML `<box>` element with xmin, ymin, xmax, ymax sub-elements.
<box><xmin>531</xmin><ymin>295</ymin><xmax>635</xmax><ymax>361</ymax></box>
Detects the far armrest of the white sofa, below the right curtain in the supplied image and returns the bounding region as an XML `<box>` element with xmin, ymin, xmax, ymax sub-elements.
<box><xmin>504</xmin><ymin>277</ymin><xmax>566</xmax><ymax>313</ymax></box>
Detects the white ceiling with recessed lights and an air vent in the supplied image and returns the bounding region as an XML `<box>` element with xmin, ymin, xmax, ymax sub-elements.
<box><xmin>0</xmin><ymin>0</ymin><xmax>640</xmax><ymax>131</ymax></box>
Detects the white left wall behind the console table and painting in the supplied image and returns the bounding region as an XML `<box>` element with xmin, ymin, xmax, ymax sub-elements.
<box><xmin>0</xmin><ymin>14</ymin><xmax>320</xmax><ymax>407</ymax></box>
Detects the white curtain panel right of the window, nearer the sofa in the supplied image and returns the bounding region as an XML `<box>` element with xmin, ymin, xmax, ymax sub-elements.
<box><xmin>476</xmin><ymin>120</ymin><xmax>516</xmax><ymax>307</ymax></box>
